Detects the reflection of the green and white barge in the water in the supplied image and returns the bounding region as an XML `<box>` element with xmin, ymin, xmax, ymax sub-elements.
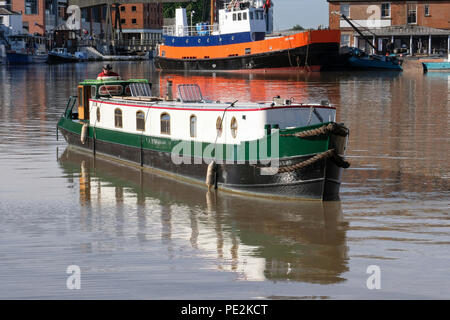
<box><xmin>59</xmin><ymin>147</ymin><xmax>348</xmax><ymax>284</ymax></box>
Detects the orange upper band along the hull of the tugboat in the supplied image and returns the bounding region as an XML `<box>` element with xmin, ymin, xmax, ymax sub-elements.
<box><xmin>158</xmin><ymin>30</ymin><xmax>340</xmax><ymax>59</ymax></box>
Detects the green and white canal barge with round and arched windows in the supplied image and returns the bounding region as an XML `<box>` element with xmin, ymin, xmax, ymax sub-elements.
<box><xmin>57</xmin><ymin>79</ymin><xmax>349</xmax><ymax>200</ymax></box>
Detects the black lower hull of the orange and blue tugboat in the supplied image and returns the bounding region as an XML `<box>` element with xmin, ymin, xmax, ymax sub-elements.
<box><xmin>155</xmin><ymin>43</ymin><xmax>339</xmax><ymax>71</ymax></box>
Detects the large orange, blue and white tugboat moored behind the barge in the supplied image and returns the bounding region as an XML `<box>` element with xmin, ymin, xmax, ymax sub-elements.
<box><xmin>155</xmin><ymin>0</ymin><xmax>340</xmax><ymax>72</ymax></box>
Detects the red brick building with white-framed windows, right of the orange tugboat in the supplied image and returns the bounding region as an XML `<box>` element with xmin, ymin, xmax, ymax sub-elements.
<box><xmin>327</xmin><ymin>0</ymin><xmax>450</xmax><ymax>54</ymax></box>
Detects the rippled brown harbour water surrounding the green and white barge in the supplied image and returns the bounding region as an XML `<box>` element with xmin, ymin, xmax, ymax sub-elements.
<box><xmin>0</xmin><ymin>62</ymin><xmax>450</xmax><ymax>299</ymax></box>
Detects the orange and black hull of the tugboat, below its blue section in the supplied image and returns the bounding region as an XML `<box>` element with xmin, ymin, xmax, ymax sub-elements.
<box><xmin>155</xmin><ymin>30</ymin><xmax>341</xmax><ymax>72</ymax></box>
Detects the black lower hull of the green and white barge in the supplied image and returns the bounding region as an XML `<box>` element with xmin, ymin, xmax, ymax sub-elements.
<box><xmin>59</xmin><ymin>127</ymin><xmax>343</xmax><ymax>200</ymax></box>
